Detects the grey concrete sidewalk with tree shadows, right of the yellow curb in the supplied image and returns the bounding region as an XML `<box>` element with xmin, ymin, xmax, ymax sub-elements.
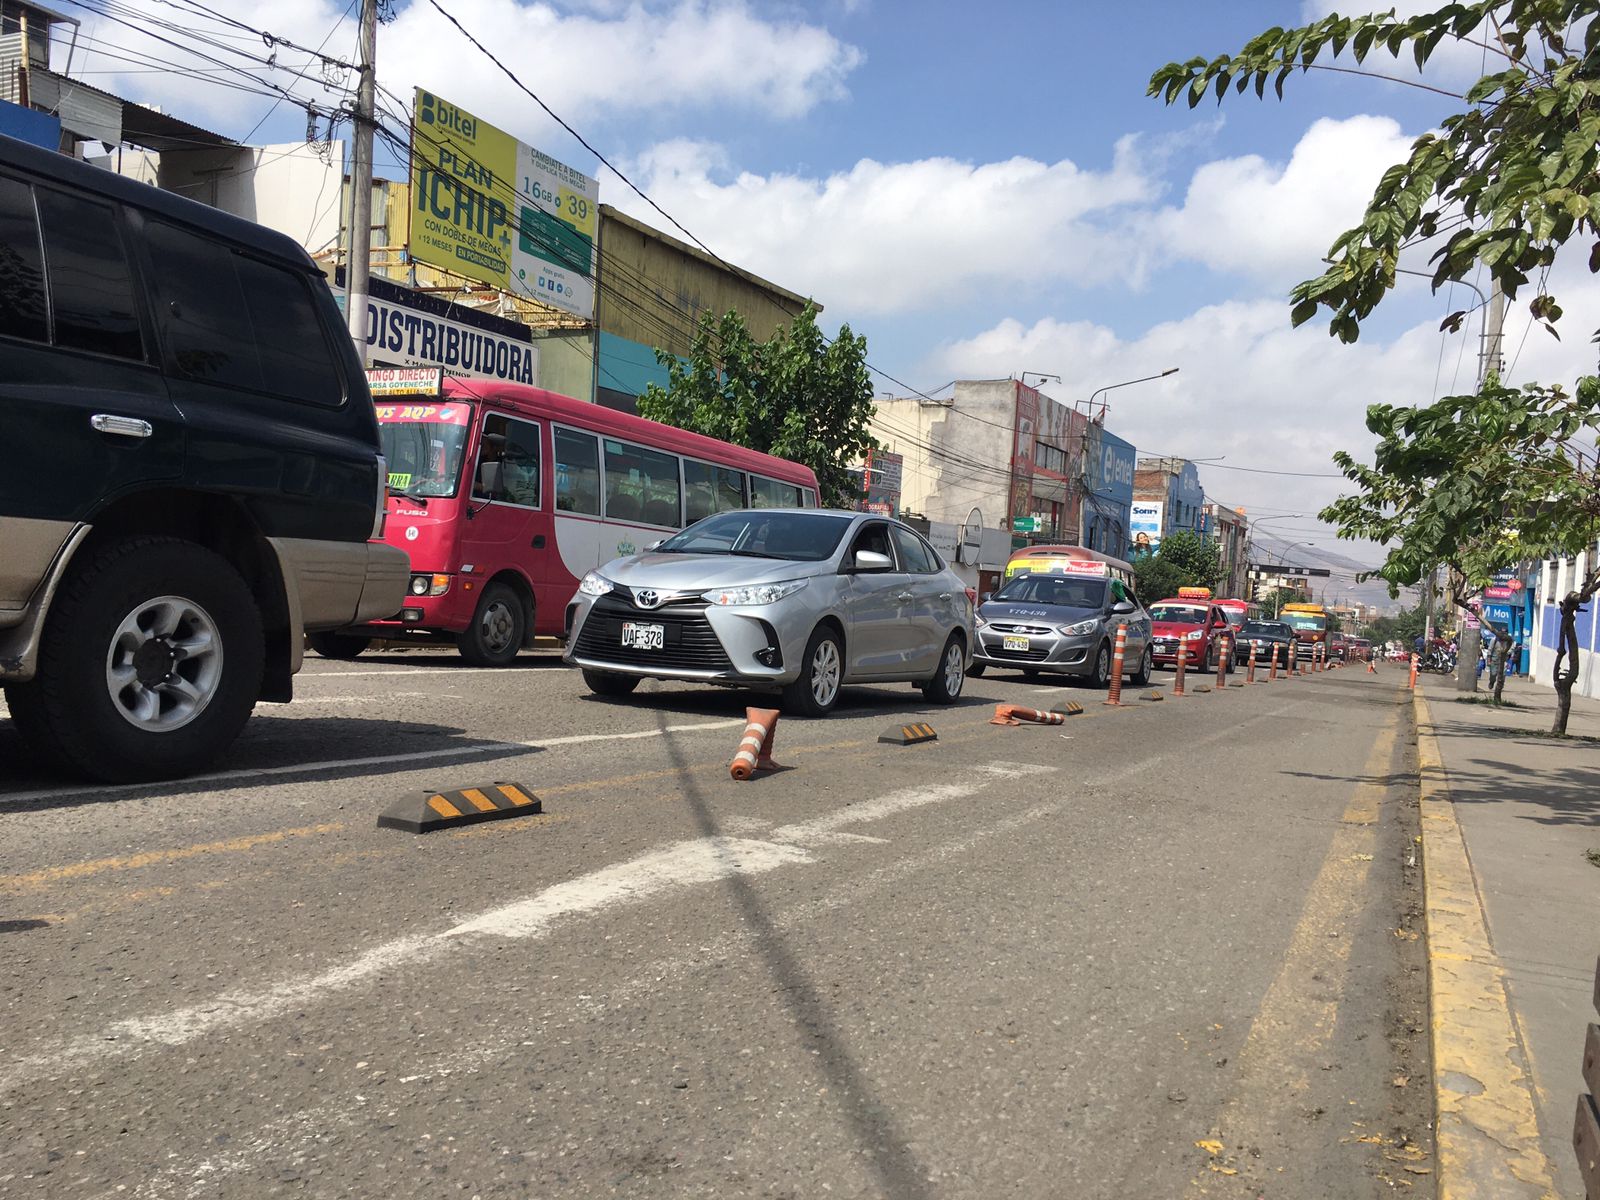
<box><xmin>1418</xmin><ymin>675</ymin><xmax>1600</xmax><ymax>1200</ymax></box>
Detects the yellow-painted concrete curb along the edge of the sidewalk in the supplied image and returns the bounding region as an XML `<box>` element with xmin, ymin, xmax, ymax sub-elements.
<box><xmin>1411</xmin><ymin>691</ymin><xmax>1555</xmax><ymax>1200</ymax></box>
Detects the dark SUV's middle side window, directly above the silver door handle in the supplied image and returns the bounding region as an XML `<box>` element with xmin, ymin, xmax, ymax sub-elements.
<box><xmin>35</xmin><ymin>189</ymin><xmax>144</xmax><ymax>358</ymax></box>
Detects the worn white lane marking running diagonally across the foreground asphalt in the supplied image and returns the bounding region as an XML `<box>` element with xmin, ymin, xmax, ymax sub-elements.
<box><xmin>0</xmin><ymin>763</ymin><xmax>1054</xmax><ymax>1093</ymax></box>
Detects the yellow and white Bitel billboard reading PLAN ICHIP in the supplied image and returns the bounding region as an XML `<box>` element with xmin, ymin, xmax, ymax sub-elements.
<box><xmin>410</xmin><ymin>88</ymin><xmax>600</xmax><ymax>317</ymax></box>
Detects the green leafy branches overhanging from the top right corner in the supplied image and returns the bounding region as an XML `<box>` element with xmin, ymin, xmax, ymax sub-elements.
<box><xmin>1149</xmin><ymin>0</ymin><xmax>1600</xmax><ymax>342</ymax></box>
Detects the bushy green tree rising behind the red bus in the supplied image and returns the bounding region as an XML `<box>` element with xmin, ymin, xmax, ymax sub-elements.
<box><xmin>638</xmin><ymin>304</ymin><xmax>877</xmax><ymax>507</ymax></box>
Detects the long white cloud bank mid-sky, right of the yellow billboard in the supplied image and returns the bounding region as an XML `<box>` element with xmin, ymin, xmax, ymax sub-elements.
<box><xmin>602</xmin><ymin>138</ymin><xmax>1157</xmax><ymax>315</ymax></box>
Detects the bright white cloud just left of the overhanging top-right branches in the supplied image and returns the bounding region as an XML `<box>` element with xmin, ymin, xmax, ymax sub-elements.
<box><xmin>1152</xmin><ymin>117</ymin><xmax>1414</xmax><ymax>280</ymax></box>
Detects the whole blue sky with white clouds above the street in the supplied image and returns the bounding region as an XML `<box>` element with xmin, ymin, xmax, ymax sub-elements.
<box><xmin>65</xmin><ymin>0</ymin><xmax>1600</xmax><ymax>569</ymax></box>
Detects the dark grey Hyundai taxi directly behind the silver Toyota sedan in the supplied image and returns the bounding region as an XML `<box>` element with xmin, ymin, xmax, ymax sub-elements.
<box><xmin>971</xmin><ymin>560</ymin><xmax>1155</xmax><ymax>688</ymax></box>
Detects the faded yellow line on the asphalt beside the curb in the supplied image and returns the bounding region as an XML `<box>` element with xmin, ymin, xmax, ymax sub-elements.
<box><xmin>1189</xmin><ymin>691</ymin><xmax>1403</xmax><ymax>1195</ymax></box>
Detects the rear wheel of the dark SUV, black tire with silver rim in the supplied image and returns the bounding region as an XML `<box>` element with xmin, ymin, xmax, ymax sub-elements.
<box><xmin>13</xmin><ymin>536</ymin><xmax>266</xmax><ymax>782</ymax></box>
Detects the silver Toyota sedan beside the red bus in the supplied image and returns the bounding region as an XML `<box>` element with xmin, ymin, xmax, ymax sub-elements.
<box><xmin>566</xmin><ymin>509</ymin><xmax>973</xmax><ymax>717</ymax></box>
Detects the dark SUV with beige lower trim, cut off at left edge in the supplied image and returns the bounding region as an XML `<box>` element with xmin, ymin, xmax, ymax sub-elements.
<box><xmin>0</xmin><ymin>136</ymin><xmax>408</xmax><ymax>781</ymax></box>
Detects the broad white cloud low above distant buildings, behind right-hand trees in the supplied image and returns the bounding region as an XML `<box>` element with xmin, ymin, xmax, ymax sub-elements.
<box><xmin>920</xmin><ymin>277</ymin><xmax>1600</xmax><ymax>534</ymax></box>
